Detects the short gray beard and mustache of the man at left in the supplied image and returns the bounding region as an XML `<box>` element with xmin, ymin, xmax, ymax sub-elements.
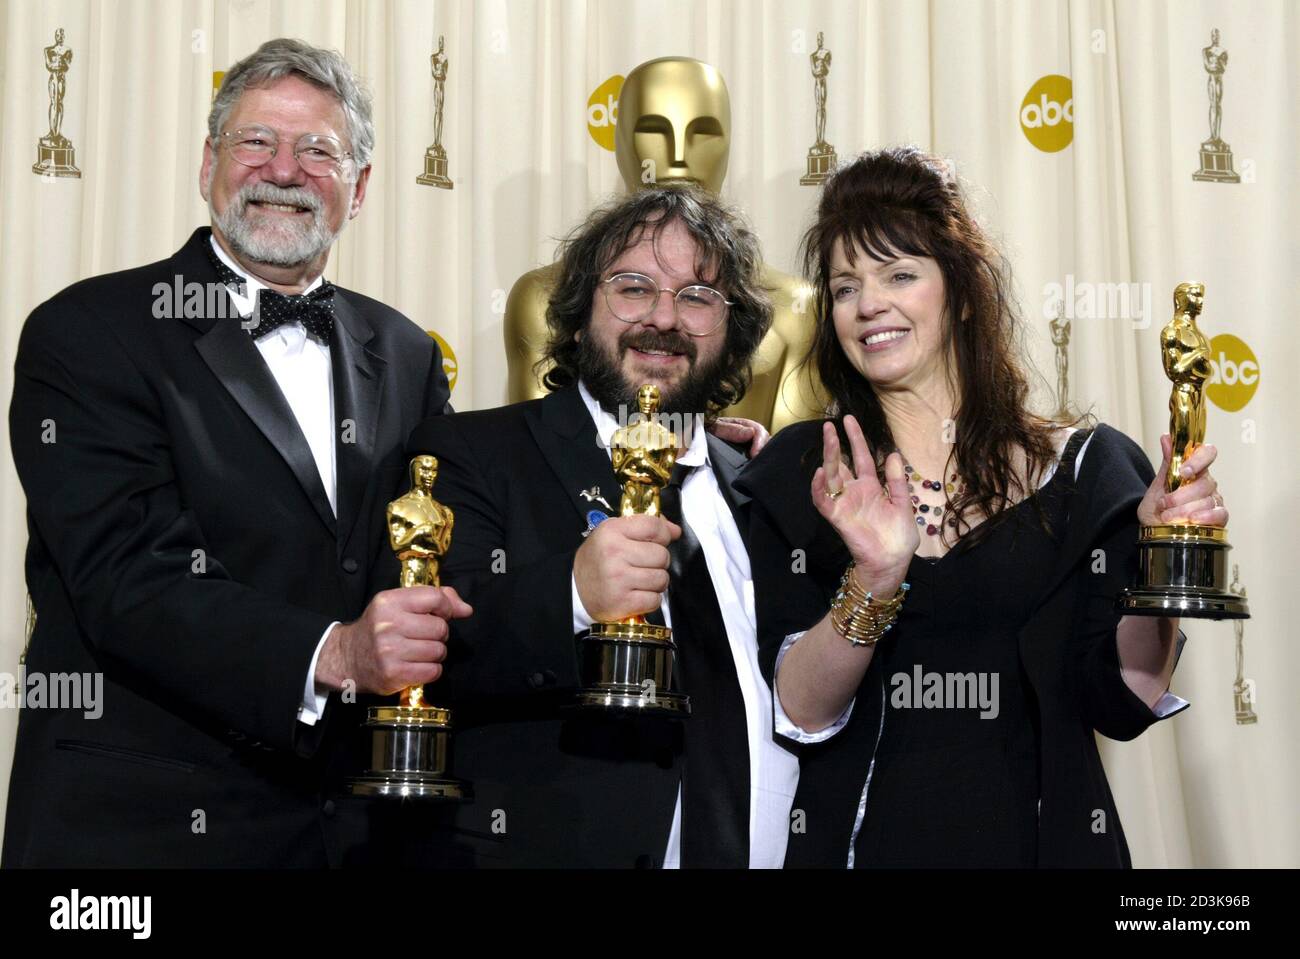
<box><xmin>208</xmin><ymin>183</ymin><xmax>347</xmax><ymax>266</ymax></box>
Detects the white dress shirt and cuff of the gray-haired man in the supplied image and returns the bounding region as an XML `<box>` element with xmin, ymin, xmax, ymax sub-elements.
<box><xmin>208</xmin><ymin>238</ymin><xmax>338</xmax><ymax>726</ymax></box>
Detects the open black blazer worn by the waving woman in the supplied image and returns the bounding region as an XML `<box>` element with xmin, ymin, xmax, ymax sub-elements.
<box><xmin>737</xmin><ymin>422</ymin><xmax>1175</xmax><ymax>868</ymax></box>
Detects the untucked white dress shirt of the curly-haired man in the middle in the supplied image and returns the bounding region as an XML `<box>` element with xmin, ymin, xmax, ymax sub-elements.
<box><xmin>572</xmin><ymin>383</ymin><xmax>800</xmax><ymax>869</ymax></box>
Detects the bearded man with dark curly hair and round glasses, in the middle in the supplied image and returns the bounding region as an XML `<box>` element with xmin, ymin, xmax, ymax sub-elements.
<box><xmin>408</xmin><ymin>186</ymin><xmax>798</xmax><ymax>868</ymax></box>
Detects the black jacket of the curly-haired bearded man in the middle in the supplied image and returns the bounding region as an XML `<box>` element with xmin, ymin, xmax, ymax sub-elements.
<box><xmin>408</xmin><ymin>387</ymin><xmax>745</xmax><ymax>868</ymax></box>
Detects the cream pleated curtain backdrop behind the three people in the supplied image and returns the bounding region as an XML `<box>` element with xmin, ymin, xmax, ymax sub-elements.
<box><xmin>0</xmin><ymin>0</ymin><xmax>1300</xmax><ymax>867</ymax></box>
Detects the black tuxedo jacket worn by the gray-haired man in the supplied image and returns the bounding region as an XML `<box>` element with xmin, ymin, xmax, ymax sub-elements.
<box><xmin>4</xmin><ymin>229</ymin><xmax>449</xmax><ymax>867</ymax></box>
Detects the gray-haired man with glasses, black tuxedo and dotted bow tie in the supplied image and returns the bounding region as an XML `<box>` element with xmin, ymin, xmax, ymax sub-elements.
<box><xmin>4</xmin><ymin>40</ymin><xmax>469</xmax><ymax>867</ymax></box>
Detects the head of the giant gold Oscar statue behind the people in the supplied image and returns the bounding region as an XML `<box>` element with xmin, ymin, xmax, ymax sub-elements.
<box><xmin>614</xmin><ymin>57</ymin><xmax>731</xmax><ymax>194</ymax></box>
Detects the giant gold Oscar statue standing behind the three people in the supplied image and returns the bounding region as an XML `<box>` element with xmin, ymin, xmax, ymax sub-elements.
<box><xmin>504</xmin><ymin>57</ymin><xmax>822</xmax><ymax>433</ymax></box>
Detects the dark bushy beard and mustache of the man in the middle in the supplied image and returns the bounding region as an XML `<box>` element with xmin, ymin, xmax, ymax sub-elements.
<box><xmin>576</xmin><ymin>329</ymin><xmax>727</xmax><ymax>417</ymax></box>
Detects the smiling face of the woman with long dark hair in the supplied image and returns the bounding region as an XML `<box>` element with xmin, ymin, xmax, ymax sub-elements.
<box><xmin>831</xmin><ymin>240</ymin><xmax>946</xmax><ymax>389</ymax></box>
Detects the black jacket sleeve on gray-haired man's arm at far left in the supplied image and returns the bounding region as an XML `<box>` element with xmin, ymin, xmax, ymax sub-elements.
<box><xmin>9</xmin><ymin>294</ymin><xmax>330</xmax><ymax>748</ymax></box>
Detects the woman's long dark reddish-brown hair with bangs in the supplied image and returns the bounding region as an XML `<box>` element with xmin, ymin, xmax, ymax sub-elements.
<box><xmin>802</xmin><ymin>147</ymin><xmax>1071</xmax><ymax>546</ymax></box>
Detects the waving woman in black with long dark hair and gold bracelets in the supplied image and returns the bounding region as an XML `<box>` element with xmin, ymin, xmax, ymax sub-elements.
<box><xmin>738</xmin><ymin>148</ymin><xmax>1227</xmax><ymax>868</ymax></box>
